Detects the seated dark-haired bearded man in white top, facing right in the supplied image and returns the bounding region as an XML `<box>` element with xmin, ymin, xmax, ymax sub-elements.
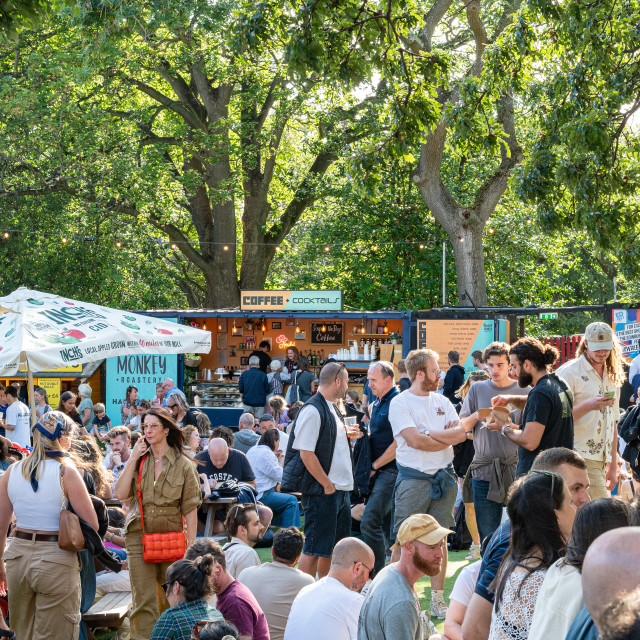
<box><xmin>222</xmin><ymin>503</ymin><xmax>264</xmax><ymax>578</ymax></box>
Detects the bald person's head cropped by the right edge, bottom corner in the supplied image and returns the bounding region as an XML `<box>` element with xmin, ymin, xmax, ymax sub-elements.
<box><xmin>567</xmin><ymin>527</ymin><xmax>640</xmax><ymax>640</ymax></box>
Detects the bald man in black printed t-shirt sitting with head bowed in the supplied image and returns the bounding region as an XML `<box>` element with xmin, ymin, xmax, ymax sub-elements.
<box><xmin>196</xmin><ymin>438</ymin><xmax>256</xmax><ymax>533</ymax></box>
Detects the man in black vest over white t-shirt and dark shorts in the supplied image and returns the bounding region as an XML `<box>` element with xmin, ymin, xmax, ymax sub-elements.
<box><xmin>282</xmin><ymin>362</ymin><xmax>353</xmax><ymax>578</ymax></box>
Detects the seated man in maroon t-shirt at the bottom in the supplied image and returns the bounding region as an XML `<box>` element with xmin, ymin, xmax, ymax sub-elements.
<box><xmin>184</xmin><ymin>538</ymin><xmax>269</xmax><ymax>640</ymax></box>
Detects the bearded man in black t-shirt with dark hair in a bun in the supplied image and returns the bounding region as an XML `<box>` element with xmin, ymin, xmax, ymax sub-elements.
<box><xmin>486</xmin><ymin>338</ymin><xmax>573</xmax><ymax>476</ymax></box>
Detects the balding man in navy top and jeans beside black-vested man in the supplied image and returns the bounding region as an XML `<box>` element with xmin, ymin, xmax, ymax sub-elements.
<box><xmin>360</xmin><ymin>360</ymin><xmax>399</xmax><ymax>571</ymax></box>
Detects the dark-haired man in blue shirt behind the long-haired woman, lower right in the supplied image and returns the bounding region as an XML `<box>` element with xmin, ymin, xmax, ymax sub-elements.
<box><xmin>462</xmin><ymin>447</ymin><xmax>590</xmax><ymax>640</ymax></box>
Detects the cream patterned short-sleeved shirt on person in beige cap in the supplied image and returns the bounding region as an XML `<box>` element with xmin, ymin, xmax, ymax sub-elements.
<box><xmin>556</xmin><ymin>354</ymin><xmax>620</xmax><ymax>462</ymax></box>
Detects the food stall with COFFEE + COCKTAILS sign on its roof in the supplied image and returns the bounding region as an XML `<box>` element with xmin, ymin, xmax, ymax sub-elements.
<box><xmin>147</xmin><ymin>291</ymin><xmax>411</xmax><ymax>427</ymax></box>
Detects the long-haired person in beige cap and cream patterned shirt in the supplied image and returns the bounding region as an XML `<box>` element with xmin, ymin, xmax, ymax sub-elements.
<box><xmin>558</xmin><ymin>322</ymin><xmax>624</xmax><ymax>500</ymax></box>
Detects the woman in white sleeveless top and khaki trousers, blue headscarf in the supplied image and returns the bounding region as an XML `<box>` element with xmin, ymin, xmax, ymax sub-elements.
<box><xmin>0</xmin><ymin>411</ymin><xmax>98</xmax><ymax>640</ymax></box>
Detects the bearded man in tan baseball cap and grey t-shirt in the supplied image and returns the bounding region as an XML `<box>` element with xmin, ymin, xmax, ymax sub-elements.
<box><xmin>358</xmin><ymin>513</ymin><xmax>453</xmax><ymax>640</ymax></box>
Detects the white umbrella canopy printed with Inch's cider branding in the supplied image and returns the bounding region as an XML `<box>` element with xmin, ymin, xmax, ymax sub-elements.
<box><xmin>0</xmin><ymin>287</ymin><xmax>211</xmax><ymax>376</ymax></box>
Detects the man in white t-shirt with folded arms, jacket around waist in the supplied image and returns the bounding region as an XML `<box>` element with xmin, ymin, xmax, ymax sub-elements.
<box><xmin>389</xmin><ymin>349</ymin><xmax>467</xmax><ymax>619</ymax></box>
